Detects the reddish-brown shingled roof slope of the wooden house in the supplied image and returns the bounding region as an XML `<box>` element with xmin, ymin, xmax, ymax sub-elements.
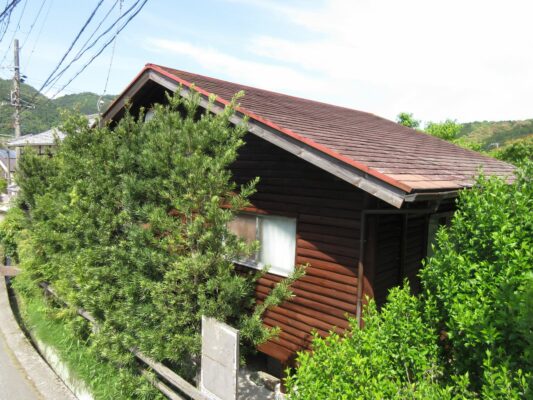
<box><xmin>134</xmin><ymin>64</ymin><xmax>514</xmax><ymax>192</ymax></box>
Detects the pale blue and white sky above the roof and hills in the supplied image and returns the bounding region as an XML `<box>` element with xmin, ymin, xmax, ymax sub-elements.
<box><xmin>0</xmin><ymin>0</ymin><xmax>533</xmax><ymax>122</ymax></box>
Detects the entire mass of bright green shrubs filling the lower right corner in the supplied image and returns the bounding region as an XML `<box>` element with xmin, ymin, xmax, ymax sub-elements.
<box><xmin>287</xmin><ymin>163</ymin><xmax>533</xmax><ymax>399</ymax></box>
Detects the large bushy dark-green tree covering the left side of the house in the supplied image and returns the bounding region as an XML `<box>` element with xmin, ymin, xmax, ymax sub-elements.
<box><xmin>7</xmin><ymin>90</ymin><xmax>302</xmax><ymax>394</ymax></box>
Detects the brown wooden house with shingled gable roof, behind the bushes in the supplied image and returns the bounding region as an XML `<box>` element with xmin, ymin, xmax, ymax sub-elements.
<box><xmin>103</xmin><ymin>64</ymin><xmax>513</xmax><ymax>376</ymax></box>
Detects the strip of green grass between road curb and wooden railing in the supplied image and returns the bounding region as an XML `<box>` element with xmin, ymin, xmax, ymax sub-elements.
<box><xmin>13</xmin><ymin>282</ymin><xmax>162</xmax><ymax>400</ymax></box>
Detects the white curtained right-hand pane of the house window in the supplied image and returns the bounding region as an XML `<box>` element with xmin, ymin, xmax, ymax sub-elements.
<box><xmin>259</xmin><ymin>216</ymin><xmax>296</xmax><ymax>276</ymax></box>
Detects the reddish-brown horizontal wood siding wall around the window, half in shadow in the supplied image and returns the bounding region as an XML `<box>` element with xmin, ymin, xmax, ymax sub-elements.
<box><xmin>232</xmin><ymin>134</ymin><xmax>366</xmax><ymax>363</ymax></box>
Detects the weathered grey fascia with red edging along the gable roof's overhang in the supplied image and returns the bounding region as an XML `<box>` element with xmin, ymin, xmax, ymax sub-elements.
<box><xmin>102</xmin><ymin>64</ymin><xmax>457</xmax><ymax>208</ymax></box>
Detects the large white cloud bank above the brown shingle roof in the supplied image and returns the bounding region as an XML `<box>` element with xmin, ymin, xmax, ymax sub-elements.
<box><xmin>145</xmin><ymin>0</ymin><xmax>533</xmax><ymax>121</ymax></box>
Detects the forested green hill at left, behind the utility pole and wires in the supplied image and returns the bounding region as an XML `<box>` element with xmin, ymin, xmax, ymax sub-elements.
<box><xmin>0</xmin><ymin>79</ymin><xmax>115</xmax><ymax>139</ymax></box>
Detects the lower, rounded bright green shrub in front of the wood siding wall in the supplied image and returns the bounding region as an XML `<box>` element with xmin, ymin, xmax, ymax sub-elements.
<box><xmin>287</xmin><ymin>284</ymin><xmax>467</xmax><ymax>400</ymax></box>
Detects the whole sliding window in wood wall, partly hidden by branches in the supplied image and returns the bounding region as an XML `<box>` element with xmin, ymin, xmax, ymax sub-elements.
<box><xmin>228</xmin><ymin>214</ymin><xmax>296</xmax><ymax>276</ymax></box>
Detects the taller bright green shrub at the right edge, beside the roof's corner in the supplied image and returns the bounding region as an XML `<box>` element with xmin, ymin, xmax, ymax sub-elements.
<box><xmin>421</xmin><ymin>164</ymin><xmax>533</xmax><ymax>394</ymax></box>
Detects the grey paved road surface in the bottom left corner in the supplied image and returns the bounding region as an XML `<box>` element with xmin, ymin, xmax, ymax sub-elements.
<box><xmin>0</xmin><ymin>324</ymin><xmax>43</xmax><ymax>400</ymax></box>
